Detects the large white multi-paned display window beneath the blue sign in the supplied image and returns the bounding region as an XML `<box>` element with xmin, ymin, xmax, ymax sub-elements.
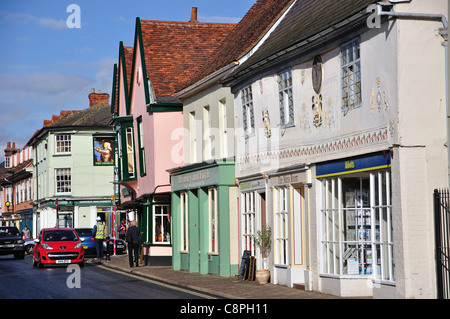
<box><xmin>319</xmin><ymin>171</ymin><xmax>394</xmax><ymax>282</ymax></box>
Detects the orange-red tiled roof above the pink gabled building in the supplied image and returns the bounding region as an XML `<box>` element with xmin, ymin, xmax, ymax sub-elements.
<box><xmin>141</xmin><ymin>20</ymin><xmax>236</xmax><ymax>97</ymax></box>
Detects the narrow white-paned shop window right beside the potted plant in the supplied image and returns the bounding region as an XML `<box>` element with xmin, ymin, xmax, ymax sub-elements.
<box><xmin>274</xmin><ymin>187</ymin><xmax>290</xmax><ymax>265</ymax></box>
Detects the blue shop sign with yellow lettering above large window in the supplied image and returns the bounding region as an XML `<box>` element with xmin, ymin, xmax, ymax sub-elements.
<box><xmin>316</xmin><ymin>151</ymin><xmax>391</xmax><ymax>178</ymax></box>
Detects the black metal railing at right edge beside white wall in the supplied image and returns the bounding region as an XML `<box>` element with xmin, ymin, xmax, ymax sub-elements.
<box><xmin>434</xmin><ymin>189</ymin><xmax>450</xmax><ymax>299</ymax></box>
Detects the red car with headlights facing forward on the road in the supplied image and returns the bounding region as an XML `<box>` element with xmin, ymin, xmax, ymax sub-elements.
<box><xmin>33</xmin><ymin>228</ymin><xmax>84</xmax><ymax>268</ymax></box>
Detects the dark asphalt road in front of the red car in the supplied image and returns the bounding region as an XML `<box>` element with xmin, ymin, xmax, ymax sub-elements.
<box><xmin>0</xmin><ymin>255</ymin><xmax>217</xmax><ymax>299</ymax></box>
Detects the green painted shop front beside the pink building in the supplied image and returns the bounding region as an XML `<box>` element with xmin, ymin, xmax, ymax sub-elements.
<box><xmin>169</xmin><ymin>161</ymin><xmax>239</xmax><ymax>277</ymax></box>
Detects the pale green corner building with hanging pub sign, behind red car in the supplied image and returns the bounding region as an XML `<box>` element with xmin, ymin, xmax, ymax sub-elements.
<box><xmin>28</xmin><ymin>92</ymin><xmax>116</xmax><ymax>233</ymax></box>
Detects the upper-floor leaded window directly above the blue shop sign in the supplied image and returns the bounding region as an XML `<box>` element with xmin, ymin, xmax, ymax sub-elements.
<box><xmin>341</xmin><ymin>38</ymin><xmax>362</xmax><ymax>111</ymax></box>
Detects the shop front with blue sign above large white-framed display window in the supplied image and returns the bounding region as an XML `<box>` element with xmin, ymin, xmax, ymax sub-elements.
<box><xmin>316</xmin><ymin>151</ymin><xmax>395</xmax><ymax>296</ymax></box>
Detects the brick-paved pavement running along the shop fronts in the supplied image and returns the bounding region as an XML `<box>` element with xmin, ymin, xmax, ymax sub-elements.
<box><xmin>96</xmin><ymin>254</ymin><xmax>343</xmax><ymax>299</ymax></box>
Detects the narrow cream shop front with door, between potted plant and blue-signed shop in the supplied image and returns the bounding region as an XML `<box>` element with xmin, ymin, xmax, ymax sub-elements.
<box><xmin>268</xmin><ymin>166</ymin><xmax>311</xmax><ymax>289</ymax></box>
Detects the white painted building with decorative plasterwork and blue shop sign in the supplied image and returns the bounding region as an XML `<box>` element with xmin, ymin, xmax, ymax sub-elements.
<box><xmin>226</xmin><ymin>0</ymin><xmax>448</xmax><ymax>298</ymax></box>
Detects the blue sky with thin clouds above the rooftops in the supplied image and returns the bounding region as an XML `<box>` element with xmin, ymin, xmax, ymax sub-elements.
<box><xmin>0</xmin><ymin>0</ymin><xmax>256</xmax><ymax>163</ymax></box>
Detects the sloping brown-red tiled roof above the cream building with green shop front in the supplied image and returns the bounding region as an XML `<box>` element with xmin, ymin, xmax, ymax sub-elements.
<box><xmin>177</xmin><ymin>0</ymin><xmax>298</xmax><ymax>90</ymax></box>
